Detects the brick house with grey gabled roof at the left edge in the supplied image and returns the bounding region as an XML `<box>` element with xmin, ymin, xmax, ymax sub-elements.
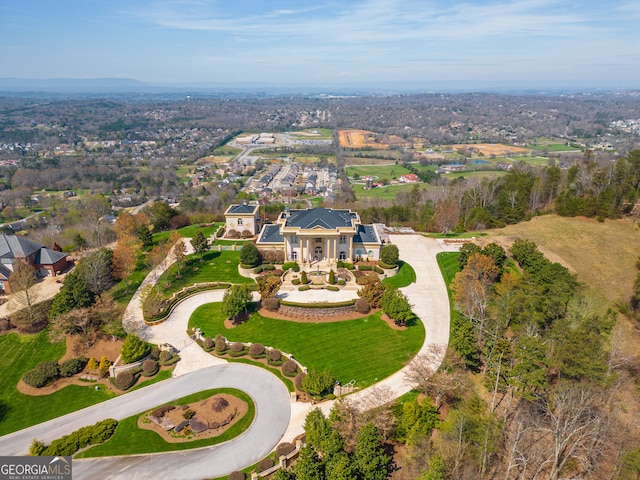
<box><xmin>0</xmin><ymin>235</ymin><xmax>67</xmax><ymax>293</ymax></box>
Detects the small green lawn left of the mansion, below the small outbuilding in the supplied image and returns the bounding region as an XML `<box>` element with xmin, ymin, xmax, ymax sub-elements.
<box><xmin>158</xmin><ymin>250</ymin><xmax>255</xmax><ymax>296</ymax></box>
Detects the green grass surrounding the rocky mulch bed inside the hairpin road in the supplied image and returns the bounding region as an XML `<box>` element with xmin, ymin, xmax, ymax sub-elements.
<box><xmin>76</xmin><ymin>388</ymin><xmax>256</xmax><ymax>458</ymax></box>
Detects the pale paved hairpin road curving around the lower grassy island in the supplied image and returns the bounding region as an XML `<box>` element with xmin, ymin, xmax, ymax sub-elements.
<box><xmin>0</xmin><ymin>364</ymin><xmax>291</xmax><ymax>480</ymax></box>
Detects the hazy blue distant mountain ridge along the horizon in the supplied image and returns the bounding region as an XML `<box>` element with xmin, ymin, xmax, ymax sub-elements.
<box><xmin>0</xmin><ymin>77</ymin><xmax>632</xmax><ymax>96</ymax></box>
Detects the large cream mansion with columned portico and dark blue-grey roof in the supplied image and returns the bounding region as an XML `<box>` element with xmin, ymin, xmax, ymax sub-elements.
<box><xmin>256</xmin><ymin>208</ymin><xmax>382</xmax><ymax>262</ymax></box>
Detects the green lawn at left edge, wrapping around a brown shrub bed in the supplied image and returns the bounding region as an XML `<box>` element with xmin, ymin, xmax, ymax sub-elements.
<box><xmin>0</xmin><ymin>332</ymin><xmax>114</xmax><ymax>435</ymax></box>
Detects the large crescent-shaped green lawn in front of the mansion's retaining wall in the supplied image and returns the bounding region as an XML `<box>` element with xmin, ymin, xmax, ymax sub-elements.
<box><xmin>189</xmin><ymin>303</ymin><xmax>425</xmax><ymax>386</ymax></box>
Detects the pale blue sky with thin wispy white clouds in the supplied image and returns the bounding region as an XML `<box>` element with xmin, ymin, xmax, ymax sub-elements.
<box><xmin>0</xmin><ymin>0</ymin><xmax>640</xmax><ymax>88</ymax></box>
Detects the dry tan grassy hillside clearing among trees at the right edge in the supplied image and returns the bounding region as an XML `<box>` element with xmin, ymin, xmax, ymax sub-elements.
<box><xmin>487</xmin><ymin>215</ymin><xmax>640</xmax><ymax>308</ymax></box>
